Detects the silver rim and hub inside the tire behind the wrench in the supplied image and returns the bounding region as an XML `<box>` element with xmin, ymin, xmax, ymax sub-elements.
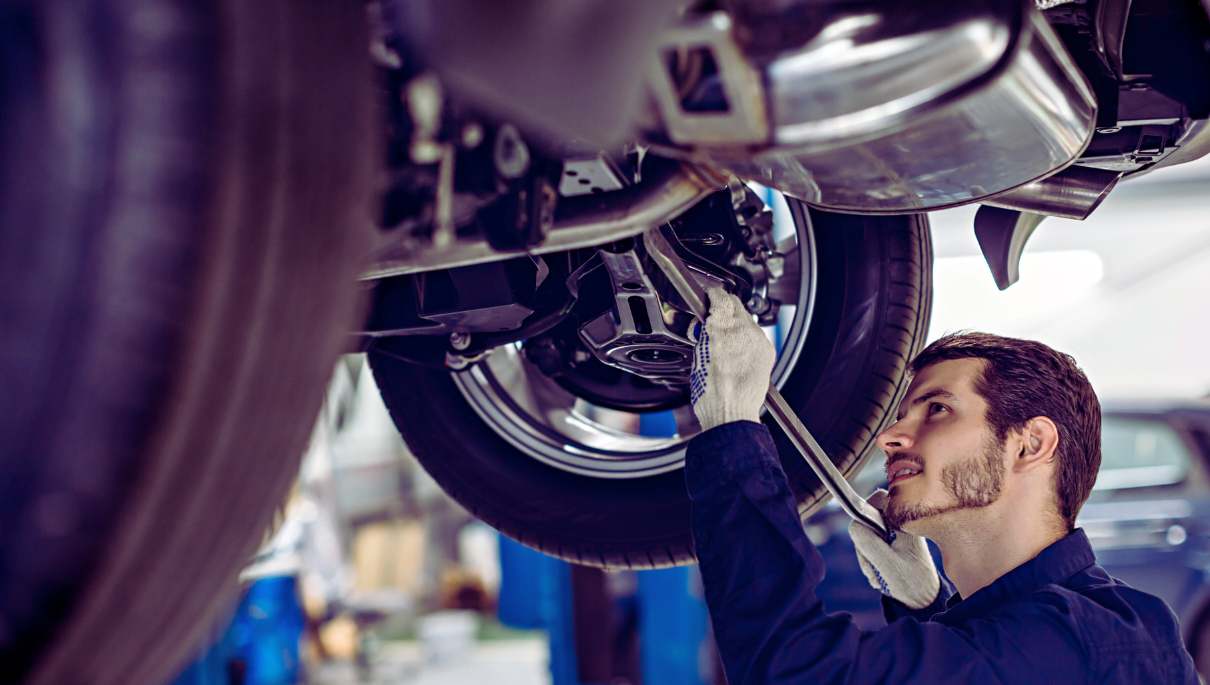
<box><xmin>453</xmin><ymin>187</ymin><xmax>816</xmax><ymax>479</ymax></box>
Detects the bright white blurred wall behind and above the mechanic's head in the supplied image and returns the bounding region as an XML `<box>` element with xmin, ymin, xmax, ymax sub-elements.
<box><xmin>930</xmin><ymin>160</ymin><xmax>1210</xmax><ymax>398</ymax></box>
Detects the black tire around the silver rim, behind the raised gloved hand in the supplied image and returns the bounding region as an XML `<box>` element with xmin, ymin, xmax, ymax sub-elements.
<box><xmin>369</xmin><ymin>202</ymin><xmax>932</xmax><ymax>569</ymax></box>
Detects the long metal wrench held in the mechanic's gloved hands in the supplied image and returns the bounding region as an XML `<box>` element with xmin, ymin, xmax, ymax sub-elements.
<box><xmin>643</xmin><ymin>226</ymin><xmax>894</xmax><ymax>543</ymax></box>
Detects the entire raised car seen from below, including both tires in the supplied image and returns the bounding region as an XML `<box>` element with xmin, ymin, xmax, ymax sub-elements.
<box><xmin>0</xmin><ymin>0</ymin><xmax>1210</xmax><ymax>683</ymax></box>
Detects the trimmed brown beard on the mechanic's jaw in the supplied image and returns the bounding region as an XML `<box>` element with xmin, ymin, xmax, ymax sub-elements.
<box><xmin>882</xmin><ymin>436</ymin><xmax>1006</xmax><ymax>530</ymax></box>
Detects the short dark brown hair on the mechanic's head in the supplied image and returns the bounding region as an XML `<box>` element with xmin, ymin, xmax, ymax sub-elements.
<box><xmin>911</xmin><ymin>330</ymin><xmax>1101</xmax><ymax>530</ymax></box>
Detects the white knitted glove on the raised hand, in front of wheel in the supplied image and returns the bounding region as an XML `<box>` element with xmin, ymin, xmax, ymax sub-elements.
<box><xmin>690</xmin><ymin>288</ymin><xmax>777</xmax><ymax>431</ymax></box>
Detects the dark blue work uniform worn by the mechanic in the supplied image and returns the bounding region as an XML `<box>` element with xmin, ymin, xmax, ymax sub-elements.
<box><xmin>685</xmin><ymin>421</ymin><xmax>1198</xmax><ymax>685</ymax></box>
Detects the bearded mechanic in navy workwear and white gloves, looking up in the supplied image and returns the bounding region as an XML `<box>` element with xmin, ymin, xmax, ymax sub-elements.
<box><xmin>685</xmin><ymin>288</ymin><xmax>1198</xmax><ymax>685</ymax></box>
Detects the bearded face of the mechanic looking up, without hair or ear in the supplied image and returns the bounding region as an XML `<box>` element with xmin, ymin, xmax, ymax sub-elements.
<box><xmin>878</xmin><ymin>359</ymin><xmax>1006</xmax><ymax>534</ymax></box>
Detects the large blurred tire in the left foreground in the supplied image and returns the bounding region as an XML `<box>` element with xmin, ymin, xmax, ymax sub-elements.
<box><xmin>0</xmin><ymin>0</ymin><xmax>375</xmax><ymax>684</ymax></box>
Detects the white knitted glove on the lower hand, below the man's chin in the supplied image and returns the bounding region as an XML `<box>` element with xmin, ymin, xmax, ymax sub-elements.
<box><xmin>848</xmin><ymin>490</ymin><xmax>941</xmax><ymax>609</ymax></box>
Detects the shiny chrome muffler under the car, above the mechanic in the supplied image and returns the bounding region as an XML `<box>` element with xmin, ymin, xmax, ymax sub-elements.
<box><xmin>646</xmin><ymin>0</ymin><xmax>1096</xmax><ymax>213</ymax></box>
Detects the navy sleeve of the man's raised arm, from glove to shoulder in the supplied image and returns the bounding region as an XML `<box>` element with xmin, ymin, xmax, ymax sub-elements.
<box><xmin>685</xmin><ymin>421</ymin><xmax>1085</xmax><ymax>685</ymax></box>
